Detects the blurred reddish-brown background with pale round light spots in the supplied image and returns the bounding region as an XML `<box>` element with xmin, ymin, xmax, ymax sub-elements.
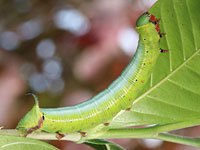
<box><xmin>0</xmin><ymin>0</ymin><xmax>197</xmax><ymax>150</ymax></box>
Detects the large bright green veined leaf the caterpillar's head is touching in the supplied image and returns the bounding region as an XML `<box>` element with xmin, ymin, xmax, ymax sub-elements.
<box><xmin>110</xmin><ymin>0</ymin><xmax>200</xmax><ymax>128</ymax></box>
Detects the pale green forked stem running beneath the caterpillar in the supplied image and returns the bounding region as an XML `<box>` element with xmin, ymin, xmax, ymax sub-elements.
<box><xmin>0</xmin><ymin>120</ymin><xmax>200</xmax><ymax>147</ymax></box>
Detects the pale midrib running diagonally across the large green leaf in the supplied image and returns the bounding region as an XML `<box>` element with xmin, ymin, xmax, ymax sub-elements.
<box><xmin>133</xmin><ymin>49</ymin><xmax>200</xmax><ymax>105</ymax></box>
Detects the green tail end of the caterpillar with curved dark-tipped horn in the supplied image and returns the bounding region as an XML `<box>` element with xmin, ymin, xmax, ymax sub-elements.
<box><xmin>16</xmin><ymin>93</ymin><xmax>43</xmax><ymax>132</ymax></box>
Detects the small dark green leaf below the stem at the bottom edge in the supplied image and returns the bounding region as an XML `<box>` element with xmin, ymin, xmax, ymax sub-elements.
<box><xmin>85</xmin><ymin>140</ymin><xmax>124</xmax><ymax>150</ymax></box>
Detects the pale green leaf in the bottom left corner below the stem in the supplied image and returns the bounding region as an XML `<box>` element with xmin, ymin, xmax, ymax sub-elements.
<box><xmin>0</xmin><ymin>135</ymin><xmax>57</xmax><ymax>150</ymax></box>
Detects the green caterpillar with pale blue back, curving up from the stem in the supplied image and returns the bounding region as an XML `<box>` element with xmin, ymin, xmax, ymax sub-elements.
<box><xmin>17</xmin><ymin>12</ymin><xmax>163</xmax><ymax>136</ymax></box>
